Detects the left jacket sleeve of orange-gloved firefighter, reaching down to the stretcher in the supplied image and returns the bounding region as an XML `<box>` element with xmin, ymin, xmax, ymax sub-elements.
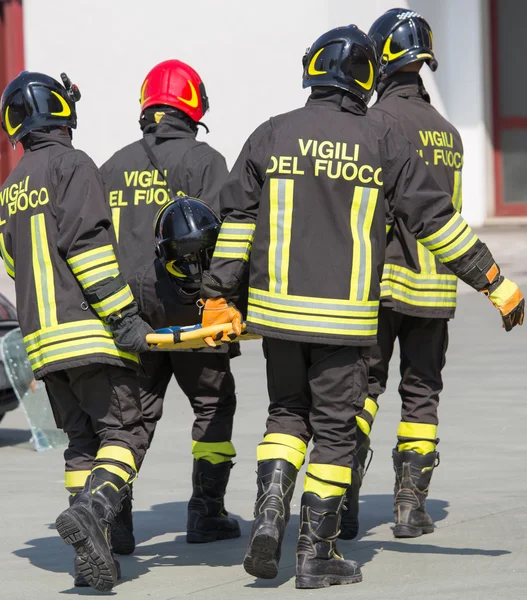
<box><xmin>202</xmin><ymin>122</ymin><xmax>272</xmax><ymax>299</ymax></box>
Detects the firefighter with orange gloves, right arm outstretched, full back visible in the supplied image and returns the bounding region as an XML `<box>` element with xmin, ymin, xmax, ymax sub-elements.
<box><xmin>202</xmin><ymin>25</ymin><xmax>524</xmax><ymax>588</ymax></box>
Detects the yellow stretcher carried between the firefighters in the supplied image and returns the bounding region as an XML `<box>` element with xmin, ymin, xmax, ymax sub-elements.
<box><xmin>146</xmin><ymin>323</ymin><xmax>261</xmax><ymax>351</ymax></box>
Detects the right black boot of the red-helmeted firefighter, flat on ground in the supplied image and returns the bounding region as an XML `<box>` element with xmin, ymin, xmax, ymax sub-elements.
<box><xmin>187</xmin><ymin>459</ymin><xmax>241</xmax><ymax>544</ymax></box>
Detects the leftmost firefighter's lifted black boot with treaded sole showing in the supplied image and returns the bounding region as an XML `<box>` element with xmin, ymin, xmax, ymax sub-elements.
<box><xmin>55</xmin><ymin>469</ymin><xmax>122</xmax><ymax>592</ymax></box>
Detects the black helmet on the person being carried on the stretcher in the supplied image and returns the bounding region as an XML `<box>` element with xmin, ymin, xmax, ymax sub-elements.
<box><xmin>154</xmin><ymin>196</ymin><xmax>221</xmax><ymax>282</ymax></box>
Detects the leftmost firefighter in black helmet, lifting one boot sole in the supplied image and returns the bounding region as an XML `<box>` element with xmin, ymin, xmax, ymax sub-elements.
<box><xmin>0</xmin><ymin>71</ymin><xmax>152</xmax><ymax>591</ymax></box>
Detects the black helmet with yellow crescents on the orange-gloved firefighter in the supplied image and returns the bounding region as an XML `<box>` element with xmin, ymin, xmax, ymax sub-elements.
<box><xmin>302</xmin><ymin>25</ymin><xmax>378</xmax><ymax>104</ymax></box>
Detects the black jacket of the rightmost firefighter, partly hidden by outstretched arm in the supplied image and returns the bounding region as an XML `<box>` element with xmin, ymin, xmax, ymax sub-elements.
<box><xmin>368</xmin><ymin>73</ymin><xmax>463</xmax><ymax>319</ymax></box>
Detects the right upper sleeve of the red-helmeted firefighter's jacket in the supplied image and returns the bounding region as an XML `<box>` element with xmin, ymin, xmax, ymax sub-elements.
<box><xmin>180</xmin><ymin>144</ymin><xmax>229</xmax><ymax>215</ymax></box>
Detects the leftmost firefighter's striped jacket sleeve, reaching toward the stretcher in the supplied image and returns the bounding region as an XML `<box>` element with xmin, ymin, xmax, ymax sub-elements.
<box><xmin>56</xmin><ymin>157</ymin><xmax>134</xmax><ymax>319</ymax></box>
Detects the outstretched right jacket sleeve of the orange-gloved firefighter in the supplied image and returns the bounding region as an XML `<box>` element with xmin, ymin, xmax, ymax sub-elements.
<box><xmin>380</xmin><ymin>130</ymin><xmax>500</xmax><ymax>291</ymax></box>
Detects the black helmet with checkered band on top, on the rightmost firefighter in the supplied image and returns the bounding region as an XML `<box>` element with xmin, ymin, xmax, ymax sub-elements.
<box><xmin>369</xmin><ymin>8</ymin><xmax>437</xmax><ymax>76</ymax></box>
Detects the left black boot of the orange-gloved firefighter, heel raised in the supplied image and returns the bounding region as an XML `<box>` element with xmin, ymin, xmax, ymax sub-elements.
<box><xmin>243</xmin><ymin>459</ymin><xmax>298</xmax><ymax>579</ymax></box>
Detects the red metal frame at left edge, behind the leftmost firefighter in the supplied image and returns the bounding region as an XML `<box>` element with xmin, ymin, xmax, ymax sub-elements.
<box><xmin>0</xmin><ymin>0</ymin><xmax>24</xmax><ymax>184</ymax></box>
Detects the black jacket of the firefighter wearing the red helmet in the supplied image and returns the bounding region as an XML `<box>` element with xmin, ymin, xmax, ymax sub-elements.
<box><xmin>101</xmin><ymin>115</ymin><xmax>228</xmax><ymax>279</ymax></box>
